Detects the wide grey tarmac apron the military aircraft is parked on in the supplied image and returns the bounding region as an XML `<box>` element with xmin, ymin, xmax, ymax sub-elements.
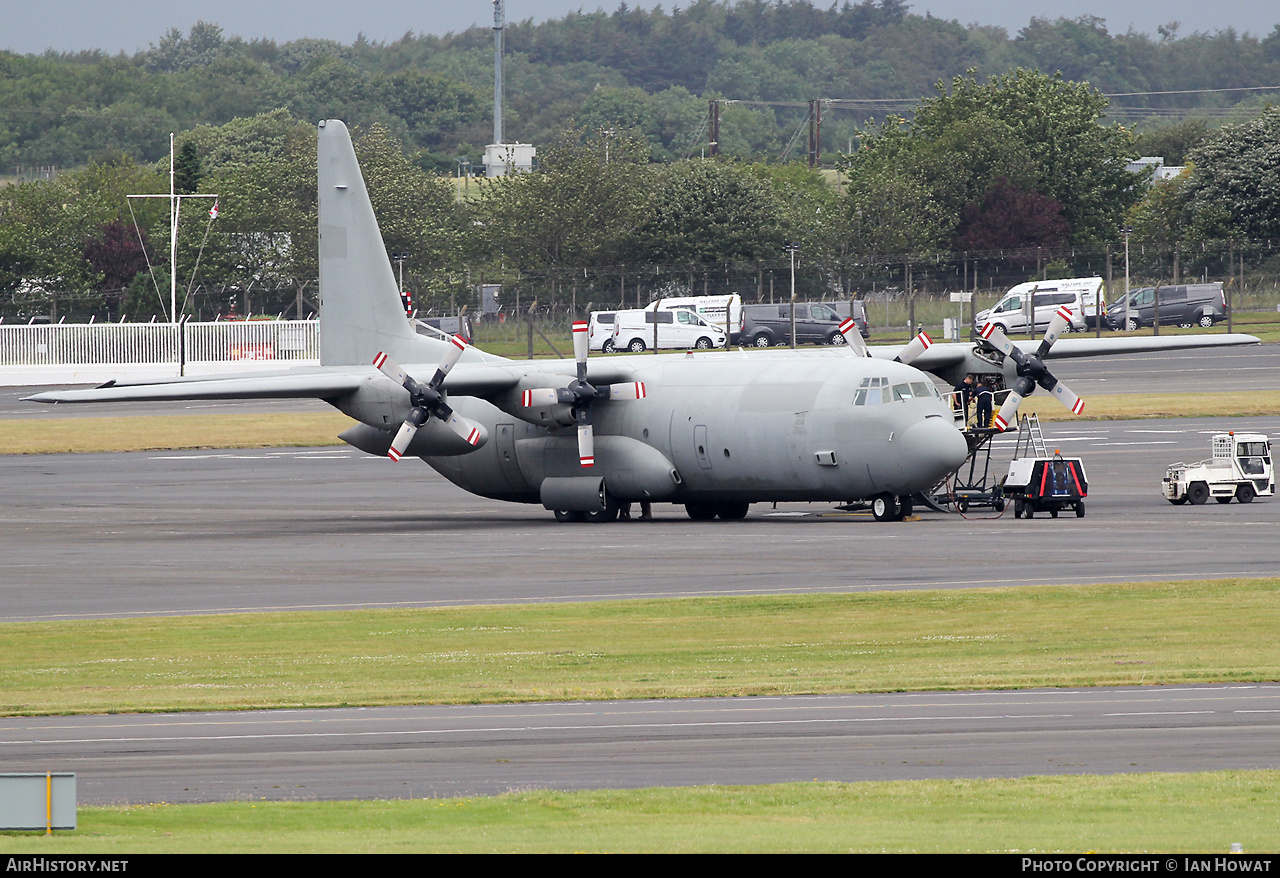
<box><xmin>0</xmin><ymin>417</ymin><xmax>1280</xmax><ymax>621</ymax></box>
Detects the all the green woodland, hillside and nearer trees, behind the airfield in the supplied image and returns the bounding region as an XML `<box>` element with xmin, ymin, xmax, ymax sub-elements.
<box><xmin>0</xmin><ymin>0</ymin><xmax>1280</xmax><ymax>316</ymax></box>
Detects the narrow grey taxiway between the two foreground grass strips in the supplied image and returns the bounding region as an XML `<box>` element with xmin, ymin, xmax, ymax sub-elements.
<box><xmin>0</xmin><ymin>685</ymin><xmax>1280</xmax><ymax>804</ymax></box>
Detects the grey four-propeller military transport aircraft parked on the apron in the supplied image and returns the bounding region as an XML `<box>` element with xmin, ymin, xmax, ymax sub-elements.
<box><xmin>29</xmin><ymin>119</ymin><xmax>1257</xmax><ymax>521</ymax></box>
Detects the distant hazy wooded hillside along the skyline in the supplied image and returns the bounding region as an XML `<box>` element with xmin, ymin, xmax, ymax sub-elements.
<box><xmin>0</xmin><ymin>0</ymin><xmax>1280</xmax><ymax>175</ymax></box>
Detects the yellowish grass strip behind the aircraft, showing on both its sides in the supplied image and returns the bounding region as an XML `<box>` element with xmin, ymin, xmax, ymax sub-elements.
<box><xmin>0</xmin><ymin>390</ymin><xmax>1280</xmax><ymax>454</ymax></box>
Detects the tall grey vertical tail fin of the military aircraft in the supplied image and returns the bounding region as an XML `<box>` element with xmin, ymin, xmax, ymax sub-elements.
<box><xmin>316</xmin><ymin>119</ymin><xmax>427</xmax><ymax>366</ymax></box>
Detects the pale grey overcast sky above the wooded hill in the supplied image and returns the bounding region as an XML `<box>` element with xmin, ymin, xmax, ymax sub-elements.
<box><xmin>0</xmin><ymin>0</ymin><xmax>1280</xmax><ymax>54</ymax></box>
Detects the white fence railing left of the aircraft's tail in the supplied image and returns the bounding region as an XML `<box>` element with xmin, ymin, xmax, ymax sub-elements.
<box><xmin>0</xmin><ymin>320</ymin><xmax>320</xmax><ymax>384</ymax></box>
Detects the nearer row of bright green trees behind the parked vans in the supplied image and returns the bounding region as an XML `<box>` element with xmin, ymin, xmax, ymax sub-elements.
<box><xmin>0</xmin><ymin>69</ymin><xmax>1280</xmax><ymax>320</ymax></box>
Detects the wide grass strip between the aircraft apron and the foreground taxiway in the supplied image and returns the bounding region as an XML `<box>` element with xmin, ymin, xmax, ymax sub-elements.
<box><xmin>0</xmin><ymin>579</ymin><xmax>1280</xmax><ymax>714</ymax></box>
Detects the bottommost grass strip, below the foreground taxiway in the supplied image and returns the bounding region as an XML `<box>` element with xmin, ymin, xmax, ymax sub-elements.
<box><xmin>0</xmin><ymin>770</ymin><xmax>1280</xmax><ymax>854</ymax></box>
